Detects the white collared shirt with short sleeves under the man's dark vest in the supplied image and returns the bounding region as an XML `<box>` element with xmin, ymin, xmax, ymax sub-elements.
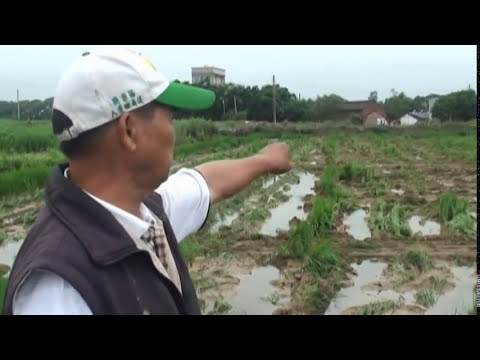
<box><xmin>13</xmin><ymin>169</ymin><xmax>210</xmax><ymax>315</ymax></box>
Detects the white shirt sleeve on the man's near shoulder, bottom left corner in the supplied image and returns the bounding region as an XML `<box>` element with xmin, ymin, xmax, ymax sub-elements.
<box><xmin>13</xmin><ymin>270</ymin><xmax>92</xmax><ymax>315</ymax></box>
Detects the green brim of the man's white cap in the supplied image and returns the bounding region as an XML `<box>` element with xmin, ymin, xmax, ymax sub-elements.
<box><xmin>157</xmin><ymin>82</ymin><xmax>215</xmax><ymax>110</ymax></box>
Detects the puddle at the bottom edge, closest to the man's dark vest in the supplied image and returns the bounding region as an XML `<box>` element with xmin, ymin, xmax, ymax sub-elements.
<box><xmin>206</xmin><ymin>266</ymin><xmax>289</xmax><ymax>315</ymax></box>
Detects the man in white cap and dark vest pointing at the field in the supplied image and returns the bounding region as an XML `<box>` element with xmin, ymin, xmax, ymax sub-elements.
<box><xmin>4</xmin><ymin>48</ymin><xmax>291</xmax><ymax>314</ymax></box>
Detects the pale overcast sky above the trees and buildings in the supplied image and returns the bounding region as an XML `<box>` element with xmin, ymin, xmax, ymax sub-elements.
<box><xmin>0</xmin><ymin>45</ymin><xmax>477</xmax><ymax>100</ymax></box>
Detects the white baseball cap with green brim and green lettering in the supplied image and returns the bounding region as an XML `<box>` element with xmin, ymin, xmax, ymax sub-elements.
<box><xmin>52</xmin><ymin>47</ymin><xmax>215</xmax><ymax>141</ymax></box>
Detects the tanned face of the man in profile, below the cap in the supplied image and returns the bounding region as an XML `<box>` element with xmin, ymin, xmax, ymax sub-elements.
<box><xmin>131</xmin><ymin>104</ymin><xmax>175</xmax><ymax>190</ymax></box>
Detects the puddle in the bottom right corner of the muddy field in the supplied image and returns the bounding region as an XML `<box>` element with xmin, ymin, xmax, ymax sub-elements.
<box><xmin>425</xmin><ymin>266</ymin><xmax>477</xmax><ymax>315</ymax></box>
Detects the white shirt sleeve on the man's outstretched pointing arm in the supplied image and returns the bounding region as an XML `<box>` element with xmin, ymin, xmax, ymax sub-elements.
<box><xmin>156</xmin><ymin>169</ymin><xmax>210</xmax><ymax>242</ymax></box>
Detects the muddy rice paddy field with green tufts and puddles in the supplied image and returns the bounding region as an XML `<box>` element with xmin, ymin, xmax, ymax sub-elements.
<box><xmin>0</xmin><ymin>119</ymin><xmax>477</xmax><ymax>315</ymax></box>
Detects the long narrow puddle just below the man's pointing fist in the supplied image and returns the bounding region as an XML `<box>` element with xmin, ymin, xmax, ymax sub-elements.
<box><xmin>260</xmin><ymin>173</ymin><xmax>317</xmax><ymax>236</ymax></box>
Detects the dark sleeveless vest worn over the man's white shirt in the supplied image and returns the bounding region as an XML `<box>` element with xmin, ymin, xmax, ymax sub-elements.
<box><xmin>3</xmin><ymin>165</ymin><xmax>201</xmax><ymax>315</ymax></box>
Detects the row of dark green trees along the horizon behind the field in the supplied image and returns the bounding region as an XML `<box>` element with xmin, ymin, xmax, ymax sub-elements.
<box><xmin>0</xmin><ymin>79</ymin><xmax>477</xmax><ymax>122</ymax></box>
